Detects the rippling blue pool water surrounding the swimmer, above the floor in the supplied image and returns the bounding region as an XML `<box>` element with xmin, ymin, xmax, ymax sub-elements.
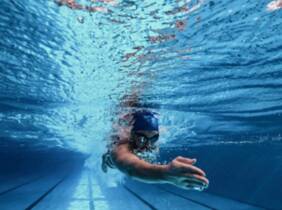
<box><xmin>0</xmin><ymin>0</ymin><xmax>282</xmax><ymax>210</ymax></box>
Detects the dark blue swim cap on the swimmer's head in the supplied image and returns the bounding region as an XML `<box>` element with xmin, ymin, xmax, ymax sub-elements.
<box><xmin>132</xmin><ymin>110</ymin><xmax>159</xmax><ymax>131</ymax></box>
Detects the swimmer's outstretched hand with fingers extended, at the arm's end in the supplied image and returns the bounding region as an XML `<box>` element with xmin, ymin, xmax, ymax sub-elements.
<box><xmin>165</xmin><ymin>156</ymin><xmax>209</xmax><ymax>191</ymax></box>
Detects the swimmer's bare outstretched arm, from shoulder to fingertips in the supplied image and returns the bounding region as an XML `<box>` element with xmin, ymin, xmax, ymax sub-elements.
<box><xmin>111</xmin><ymin>144</ymin><xmax>209</xmax><ymax>190</ymax></box>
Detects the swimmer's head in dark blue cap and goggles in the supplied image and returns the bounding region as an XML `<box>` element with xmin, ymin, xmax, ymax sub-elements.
<box><xmin>131</xmin><ymin>110</ymin><xmax>159</xmax><ymax>150</ymax></box>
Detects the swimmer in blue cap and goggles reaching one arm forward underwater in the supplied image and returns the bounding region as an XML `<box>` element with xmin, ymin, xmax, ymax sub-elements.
<box><xmin>102</xmin><ymin>110</ymin><xmax>209</xmax><ymax>191</ymax></box>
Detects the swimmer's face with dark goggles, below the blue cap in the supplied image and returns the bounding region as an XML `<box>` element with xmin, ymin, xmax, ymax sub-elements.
<box><xmin>131</xmin><ymin>130</ymin><xmax>159</xmax><ymax>149</ymax></box>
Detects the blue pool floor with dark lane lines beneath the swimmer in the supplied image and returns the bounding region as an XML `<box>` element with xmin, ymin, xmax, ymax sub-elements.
<box><xmin>0</xmin><ymin>168</ymin><xmax>261</xmax><ymax>210</ymax></box>
